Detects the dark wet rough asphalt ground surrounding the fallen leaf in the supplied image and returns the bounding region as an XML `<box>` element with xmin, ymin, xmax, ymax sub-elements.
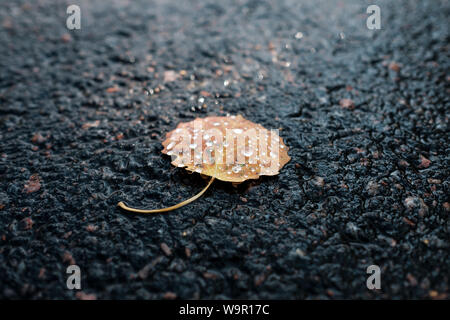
<box><xmin>0</xmin><ymin>0</ymin><xmax>450</xmax><ymax>299</ymax></box>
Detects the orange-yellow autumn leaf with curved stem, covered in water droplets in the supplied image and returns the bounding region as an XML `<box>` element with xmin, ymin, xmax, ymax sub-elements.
<box><xmin>118</xmin><ymin>115</ymin><xmax>291</xmax><ymax>213</ymax></box>
